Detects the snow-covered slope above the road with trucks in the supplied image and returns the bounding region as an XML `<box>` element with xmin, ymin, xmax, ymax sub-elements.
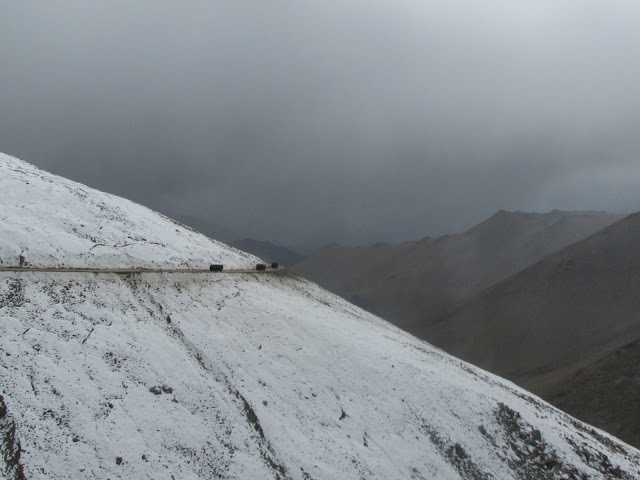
<box><xmin>0</xmin><ymin>153</ymin><xmax>258</xmax><ymax>269</ymax></box>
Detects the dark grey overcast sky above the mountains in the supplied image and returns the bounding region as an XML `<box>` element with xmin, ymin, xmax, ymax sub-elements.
<box><xmin>0</xmin><ymin>0</ymin><xmax>640</xmax><ymax>251</ymax></box>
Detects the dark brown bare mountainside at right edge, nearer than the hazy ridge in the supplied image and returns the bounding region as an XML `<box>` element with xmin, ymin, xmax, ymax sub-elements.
<box><xmin>436</xmin><ymin>214</ymin><xmax>640</xmax><ymax>445</ymax></box>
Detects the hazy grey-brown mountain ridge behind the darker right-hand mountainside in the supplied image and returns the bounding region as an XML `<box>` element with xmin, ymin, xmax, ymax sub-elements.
<box><xmin>293</xmin><ymin>210</ymin><xmax>622</xmax><ymax>339</ymax></box>
